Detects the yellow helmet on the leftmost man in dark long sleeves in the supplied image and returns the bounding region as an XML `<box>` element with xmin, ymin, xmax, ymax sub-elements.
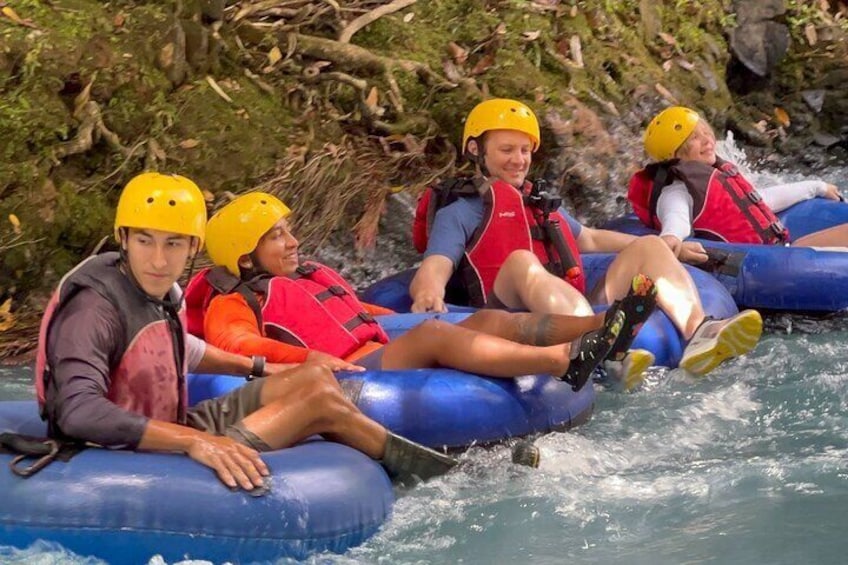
<box><xmin>115</xmin><ymin>173</ymin><xmax>206</xmax><ymax>243</ymax></box>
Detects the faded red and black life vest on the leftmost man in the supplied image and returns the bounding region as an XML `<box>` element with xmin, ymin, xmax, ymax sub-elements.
<box><xmin>35</xmin><ymin>253</ymin><xmax>188</xmax><ymax>428</ymax></box>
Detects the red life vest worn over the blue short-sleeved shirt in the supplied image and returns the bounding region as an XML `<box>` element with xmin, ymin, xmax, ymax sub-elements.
<box><xmin>413</xmin><ymin>179</ymin><xmax>586</xmax><ymax>307</ymax></box>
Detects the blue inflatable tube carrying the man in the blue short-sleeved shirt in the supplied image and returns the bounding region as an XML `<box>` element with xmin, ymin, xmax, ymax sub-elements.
<box><xmin>361</xmin><ymin>253</ymin><xmax>739</xmax><ymax>367</ymax></box>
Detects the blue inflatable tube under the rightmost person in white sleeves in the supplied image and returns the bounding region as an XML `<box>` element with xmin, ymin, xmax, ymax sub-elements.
<box><xmin>605</xmin><ymin>198</ymin><xmax>848</xmax><ymax>312</ymax></box>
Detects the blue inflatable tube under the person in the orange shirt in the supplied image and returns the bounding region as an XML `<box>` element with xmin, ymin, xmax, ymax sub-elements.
<box><xmin>189</xmin><ymin>366</ymin><xmax>595</xmax><ymax>449</ymax></box>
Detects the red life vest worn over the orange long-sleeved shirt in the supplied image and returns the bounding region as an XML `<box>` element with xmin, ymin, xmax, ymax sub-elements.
<box><xmin>186</xmin><ymin>263</ymin><xmax>389</xmax><ymax>358</ymax></box>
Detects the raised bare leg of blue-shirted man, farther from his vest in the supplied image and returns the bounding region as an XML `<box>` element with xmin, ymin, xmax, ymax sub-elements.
<box><xmin>604</xmin><ymin>235</ymin><xmax>704</xmax><ymax>340</ymax></box>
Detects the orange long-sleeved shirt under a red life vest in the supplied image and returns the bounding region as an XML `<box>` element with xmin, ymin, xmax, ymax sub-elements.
<box><xmin>203</xmin><ymin>293</ymin><xmax>393</xmax><ymax>363</ymax></box>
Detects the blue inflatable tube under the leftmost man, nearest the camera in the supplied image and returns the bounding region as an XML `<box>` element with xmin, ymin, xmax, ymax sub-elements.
<box><xmin>0</xmin><ymin>401</ymin><xmax>394</xmax><ymax>565</ymax></box>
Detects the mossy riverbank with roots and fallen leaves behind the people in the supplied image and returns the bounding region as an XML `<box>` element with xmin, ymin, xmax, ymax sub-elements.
<box><xmin>0</xmin><ymin>0</ymin><xmax>848</xmax><ymax>356</ymax></box>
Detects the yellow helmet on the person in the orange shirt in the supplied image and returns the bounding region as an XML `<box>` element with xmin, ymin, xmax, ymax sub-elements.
<box><xmin>206</xmin><ymin>192</ymin><xmax>291</xmax><ymax>276</ymax></box>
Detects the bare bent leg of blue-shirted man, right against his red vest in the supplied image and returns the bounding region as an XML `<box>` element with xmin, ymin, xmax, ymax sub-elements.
<box><xmin>486</xmin><ymin>251</ymin><xmax>592</xmax><ymax>316</ymax></box>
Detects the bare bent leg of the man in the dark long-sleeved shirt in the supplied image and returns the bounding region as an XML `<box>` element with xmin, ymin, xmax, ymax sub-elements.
<box><xmin>244</xmin><ymin>365</ymin><xmax>386</xmax><ymax>459</ymax></box>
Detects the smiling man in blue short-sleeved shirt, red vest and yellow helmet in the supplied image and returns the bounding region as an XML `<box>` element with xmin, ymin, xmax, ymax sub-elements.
<box><xmin>410</xmin><ymin>99</ymin><xmax>762</xmax><ymax>388</ymax></box>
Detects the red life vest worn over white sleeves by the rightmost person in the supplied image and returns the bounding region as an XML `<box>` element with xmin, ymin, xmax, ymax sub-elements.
<box><xmin>627</xmin><ymin>159</ymin><xmax>789</xmax><ymax>244</ymax></box>
